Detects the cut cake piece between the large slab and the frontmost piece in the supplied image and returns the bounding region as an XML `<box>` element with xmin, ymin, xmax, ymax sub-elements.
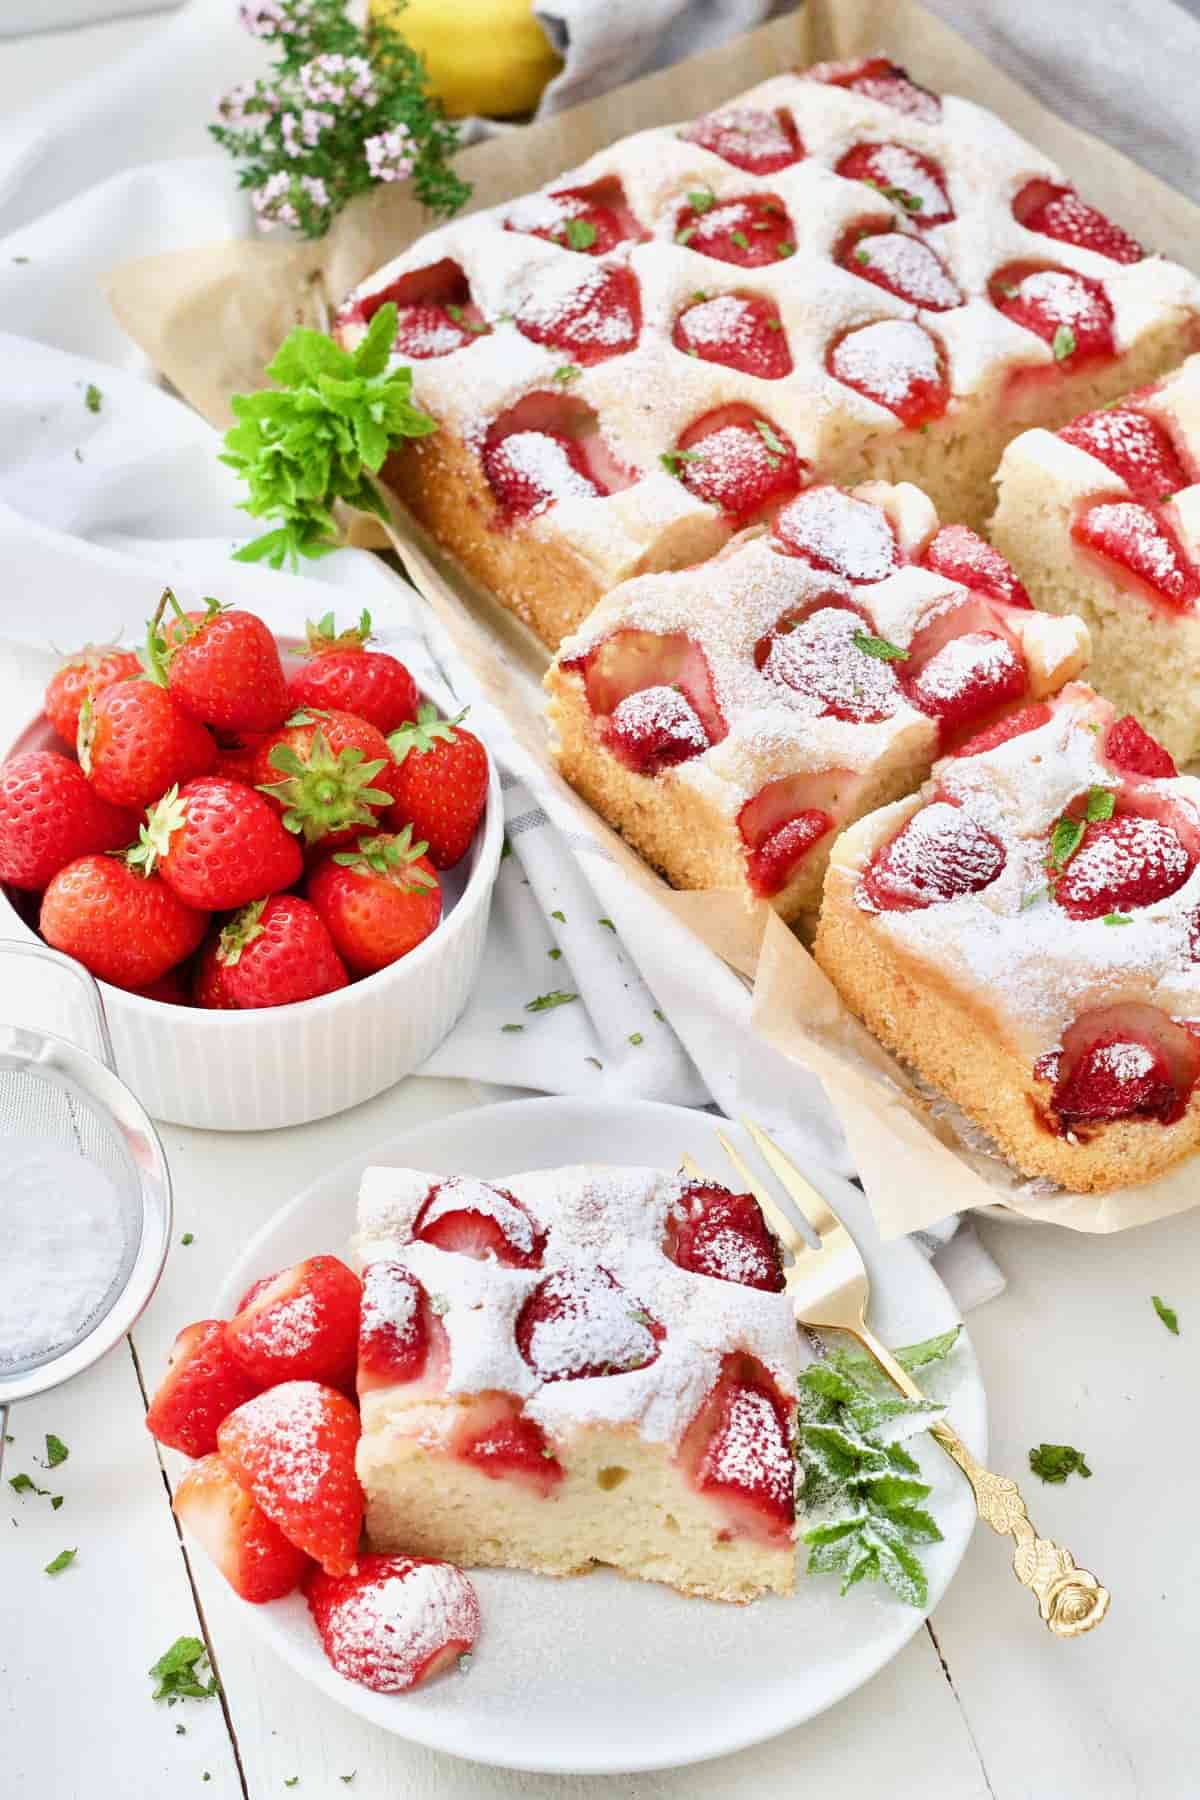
<box><xmin>545</xmin><ymin>484</ymin><xmax>1087</xmax><ymax>934</ymax></box>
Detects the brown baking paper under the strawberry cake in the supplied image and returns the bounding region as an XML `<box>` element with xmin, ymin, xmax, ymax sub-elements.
<box><xmin>104</xmin><ymin>0</ymin><xmax>1200</xmax><ymax>1237</ymax></box>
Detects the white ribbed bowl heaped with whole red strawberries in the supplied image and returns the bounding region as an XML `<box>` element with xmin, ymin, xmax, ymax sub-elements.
<box><xmin>0</xmin><ymin>590</ymin><xmax>504</xmax><ymax>1130</ymax></box>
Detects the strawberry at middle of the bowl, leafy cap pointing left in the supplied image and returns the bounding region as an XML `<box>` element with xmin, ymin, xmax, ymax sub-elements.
<box><xmin>130</xmin><ymin>776</ymin><xmax>304</xmax><ymax>913</ymax></box>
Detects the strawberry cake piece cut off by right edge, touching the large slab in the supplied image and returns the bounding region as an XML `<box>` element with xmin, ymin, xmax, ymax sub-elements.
<box><xmin>991</xmin><ymin>356</ymin><xmax>1200</xmax><ymax>761</ymax></box>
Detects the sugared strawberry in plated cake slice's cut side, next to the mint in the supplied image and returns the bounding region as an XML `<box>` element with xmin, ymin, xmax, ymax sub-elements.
<box><xmin>680</xmin><ymin>1352</ymin><xmax>795</xmax><ymax>1543</ymax></box>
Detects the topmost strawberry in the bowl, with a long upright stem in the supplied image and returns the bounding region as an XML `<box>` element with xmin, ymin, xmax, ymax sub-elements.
<box><xmin>146</xmin><ymin>589</ymin><xmax>288</xmax><ymax>731</ymax></box>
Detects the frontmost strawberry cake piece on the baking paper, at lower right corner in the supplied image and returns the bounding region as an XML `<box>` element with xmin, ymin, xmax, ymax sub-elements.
<box><xmin>817</xmin><ymin>682</ymin><xmax>1200</xmax><ymax>1193</ymax></box>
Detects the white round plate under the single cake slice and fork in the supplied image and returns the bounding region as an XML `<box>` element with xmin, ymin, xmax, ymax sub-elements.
<box><xmin>218</xmin><ymin>1098</ymin><xmax>988</xmax><ymax>1775</ymax></box>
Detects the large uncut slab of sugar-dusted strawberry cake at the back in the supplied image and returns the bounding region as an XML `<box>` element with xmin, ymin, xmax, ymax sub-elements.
<box><xmin>335</xmin><ymin>58</ymin><xmax>1200</xmax><ymax>646</ymax></box>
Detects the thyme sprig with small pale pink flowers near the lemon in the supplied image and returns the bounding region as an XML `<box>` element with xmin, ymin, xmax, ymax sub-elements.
<box><xmin>209</xmin><ymin>0</ymin><xmax>471</xmax><ymax>238</ymax></box>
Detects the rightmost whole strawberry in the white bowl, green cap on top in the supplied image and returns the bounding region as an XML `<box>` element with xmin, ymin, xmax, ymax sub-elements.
<box><xmin>387</xmin><ymin>704</ymin><xmax>488</xmax><ymax>869</ymax></box>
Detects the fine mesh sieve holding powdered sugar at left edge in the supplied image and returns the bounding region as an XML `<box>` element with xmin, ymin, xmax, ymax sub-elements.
<box><xmin>0</xmin><ymin>941</ymin><xmax>171</xmax><ymax>1460</ymax></box>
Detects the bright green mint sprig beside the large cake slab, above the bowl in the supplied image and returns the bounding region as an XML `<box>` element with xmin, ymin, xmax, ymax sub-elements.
<box><xmin>221</xmin><ymin>301</ymin><xmax>437</xmax><ymax>569</ymax></box>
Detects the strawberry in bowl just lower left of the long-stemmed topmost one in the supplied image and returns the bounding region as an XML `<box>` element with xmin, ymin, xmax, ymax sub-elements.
<box><xmin>77</xmin><ymin>680</ymin><xmax>216</xmax><ymax>812</ymax></box>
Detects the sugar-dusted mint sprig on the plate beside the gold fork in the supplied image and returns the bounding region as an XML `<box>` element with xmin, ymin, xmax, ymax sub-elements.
<box><xmin>795</xmin><ymin>1327</ymin><xmax>961</xmax><ymax>1607</ymax></box>
